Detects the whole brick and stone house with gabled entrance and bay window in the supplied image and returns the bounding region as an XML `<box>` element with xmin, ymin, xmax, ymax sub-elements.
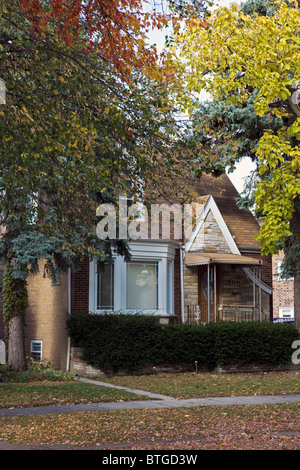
<box><xmin>0</xmin><ymin>175</ymin><xmax>272</xmax><ymax>372</ymax></box>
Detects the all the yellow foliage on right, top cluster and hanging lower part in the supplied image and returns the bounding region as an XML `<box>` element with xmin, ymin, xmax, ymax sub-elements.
<box><xmin>172</xmin><ymin>0</ymin><xmax>300</xmax><ymax>258</ymax></box>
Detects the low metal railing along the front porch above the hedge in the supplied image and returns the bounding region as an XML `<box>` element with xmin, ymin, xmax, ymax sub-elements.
<box><xmin>186</xmin><ymin>304</ymin><xmax>269</xmax><ymax>324</ymax></box>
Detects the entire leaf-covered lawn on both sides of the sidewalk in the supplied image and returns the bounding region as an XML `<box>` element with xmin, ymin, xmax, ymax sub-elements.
<box><xmin>0</xmin><ymin>372</ymin><xmax>300</xmax><ymax>450</ymax></box>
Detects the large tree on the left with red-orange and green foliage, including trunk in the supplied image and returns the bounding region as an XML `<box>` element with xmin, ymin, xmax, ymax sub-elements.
<box><xmin>0</xmin><ymin>0</ymin><xmax>209</xmax><ymax>369</ymax></box>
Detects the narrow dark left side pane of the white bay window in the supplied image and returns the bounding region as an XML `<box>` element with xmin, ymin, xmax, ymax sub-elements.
<box><xmin>97</xmin><ymin>262</ymin><xmax>114</xmax><ymax>310</ymax></box>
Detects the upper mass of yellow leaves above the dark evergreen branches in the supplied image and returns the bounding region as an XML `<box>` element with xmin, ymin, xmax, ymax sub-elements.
<box><xmin>177</xmin><ymin>1</ymin><xmax>300</xmax><ymax>117</ymax></box>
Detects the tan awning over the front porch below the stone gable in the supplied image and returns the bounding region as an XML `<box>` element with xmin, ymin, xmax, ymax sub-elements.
<box><xmin>184</xmin><ymin>252</ymin><xmax>262</xmax><ymax>266</ymax></box>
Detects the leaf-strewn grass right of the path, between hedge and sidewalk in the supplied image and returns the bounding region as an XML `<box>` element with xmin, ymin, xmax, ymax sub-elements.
<box><xmin>101</xmin><ymin>372</ymin><xmax>300</xmax><ymax>399</ymax></box>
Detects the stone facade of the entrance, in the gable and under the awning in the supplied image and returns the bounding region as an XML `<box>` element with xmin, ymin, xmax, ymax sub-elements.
<box><xmin>183</xmin><ymin>209</ymin><xmax>272</xmax><ymax>322</ymax></box>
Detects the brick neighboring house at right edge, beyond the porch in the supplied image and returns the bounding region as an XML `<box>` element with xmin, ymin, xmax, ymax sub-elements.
<box><xmin>273</xmin><ymin>251</ymin><xmax>295</xmax><ymax>322</ymax></box>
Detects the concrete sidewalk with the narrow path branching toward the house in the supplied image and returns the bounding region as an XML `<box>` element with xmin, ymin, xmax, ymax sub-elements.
<box><xmin>0</xmin><ymin>378</ymin><xmax>300</xmax><ymax>417</ymax></box>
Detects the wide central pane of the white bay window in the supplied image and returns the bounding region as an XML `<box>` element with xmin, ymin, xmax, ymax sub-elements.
<box><xmin>126</xmin><ymin>261</ymin><xmax>158</xmax><ymax>310</ymax></box>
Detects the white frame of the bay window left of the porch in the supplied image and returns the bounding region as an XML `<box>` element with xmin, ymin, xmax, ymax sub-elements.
<box><xmin>89</xmin><ymin>241</ymin><xmax>177</xmax><ymax>316</ymax></box>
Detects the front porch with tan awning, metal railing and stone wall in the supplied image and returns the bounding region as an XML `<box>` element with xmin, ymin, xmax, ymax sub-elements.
<box><xmin>184</xmin><ymin>252</ymin><xmax>272</xmax><ymax>324</ymax></box>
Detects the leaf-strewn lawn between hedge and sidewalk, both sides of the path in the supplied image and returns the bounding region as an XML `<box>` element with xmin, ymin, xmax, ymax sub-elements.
<box><xmin>0</xmin><ymin>372</ymin><xmax>300</xmax><ymax>408</ymax></box>
